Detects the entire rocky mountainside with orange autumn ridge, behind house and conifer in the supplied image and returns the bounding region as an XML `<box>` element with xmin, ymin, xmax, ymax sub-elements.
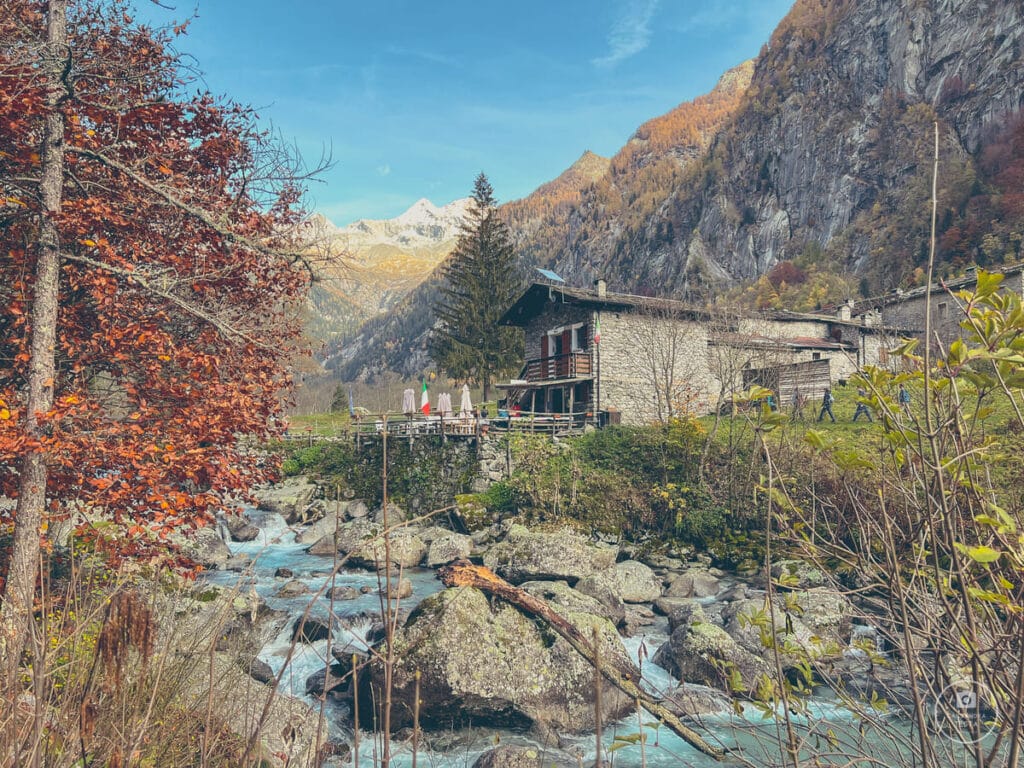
<box><xmin>325</xmin><ymin>0</ymin><xmax>1024</xmax><ymax>378</ymax></box>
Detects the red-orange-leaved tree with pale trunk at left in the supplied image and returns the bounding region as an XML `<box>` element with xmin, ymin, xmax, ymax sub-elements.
<box><xmin>0</xmin><ymin>0</ymin><xmax>311</xmax><ymax>674</ymax></box>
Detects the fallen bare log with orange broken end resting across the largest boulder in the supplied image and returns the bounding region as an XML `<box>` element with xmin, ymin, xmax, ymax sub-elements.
<box><xmin>437</xmin><ymin>560</ymin><xmax>726</xmax><ymax>760</ymax></box>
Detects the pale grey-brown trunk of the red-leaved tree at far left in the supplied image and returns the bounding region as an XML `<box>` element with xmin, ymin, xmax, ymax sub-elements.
<box><xmin>0</xmin><ymin>0</ymin><xmax>68</xmax><ymax>690</ymax></box>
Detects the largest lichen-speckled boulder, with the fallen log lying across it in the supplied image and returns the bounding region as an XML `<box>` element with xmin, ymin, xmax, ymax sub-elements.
<box><xmin>372</xmin><ymin>588</ymin><xmax>638</xmax><ymax>733</ymax></box>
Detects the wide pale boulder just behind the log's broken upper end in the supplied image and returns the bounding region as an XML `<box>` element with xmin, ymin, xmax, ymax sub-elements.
<box><xmin>483</xmin><ymin>525</ymin><xmax>618</xmax><ymax>585</ymax></box>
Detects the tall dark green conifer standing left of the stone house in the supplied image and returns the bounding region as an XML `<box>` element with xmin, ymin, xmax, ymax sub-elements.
<box><xmin>430</xmin><ymin>173</ymin><xmax>523</xmax><ymax>399</ymax></box>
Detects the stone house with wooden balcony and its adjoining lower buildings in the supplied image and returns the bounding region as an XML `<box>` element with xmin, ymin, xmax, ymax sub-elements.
<box><xmin>498</xmin><ymin>281</ymin><xmax>895</xmax><ymax>424</ymax></box>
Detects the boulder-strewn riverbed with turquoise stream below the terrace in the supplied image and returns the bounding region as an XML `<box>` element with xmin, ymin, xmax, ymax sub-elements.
<box><xmin>192</xmin><ymin>480</ymin><xmax>913</xmax><ymax>767</ymax></box>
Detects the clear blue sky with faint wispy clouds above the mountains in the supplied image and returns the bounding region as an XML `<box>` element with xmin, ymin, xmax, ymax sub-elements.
<box><xmin>140</xmin><ymin>0</ymin><xmax>793</xmax><ymax>224</ymax></box>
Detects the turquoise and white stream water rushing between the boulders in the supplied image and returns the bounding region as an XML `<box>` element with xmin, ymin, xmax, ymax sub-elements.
<box><xmin>206</xmin><ymin>510</ymin><xmax>999</xmax><ymax>768</ymax></box>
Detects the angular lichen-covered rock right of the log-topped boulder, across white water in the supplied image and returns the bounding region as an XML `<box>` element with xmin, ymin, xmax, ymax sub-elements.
<box><xmin>653</xmin><ymin>603</ymin><xmax>770</xmax><ymax>694</ymax></box>
